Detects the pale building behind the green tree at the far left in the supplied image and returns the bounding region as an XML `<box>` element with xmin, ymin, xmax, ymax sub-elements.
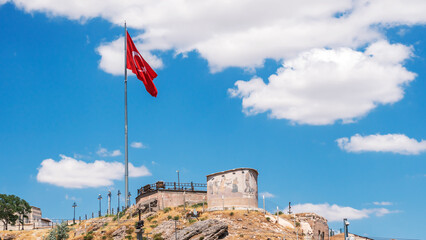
<box><xmin>0</xmin><ymin>206</ymin><xmax>51</xmax><ymax>230</ymax></box>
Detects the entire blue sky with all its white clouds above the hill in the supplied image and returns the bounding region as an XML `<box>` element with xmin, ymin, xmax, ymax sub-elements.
<box><xmin>0</xmin><ymin>0</ymin><xmax>426</xmax><ymax>239</ymax></box>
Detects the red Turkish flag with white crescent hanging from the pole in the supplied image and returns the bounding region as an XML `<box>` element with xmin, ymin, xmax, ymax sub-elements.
<box><xmin>127</xmin><ymin>32</ymin><xmax>158</xmax><ymax>97</ymax></box>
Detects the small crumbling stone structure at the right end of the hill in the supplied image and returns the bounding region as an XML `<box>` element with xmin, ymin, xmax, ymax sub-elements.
<box><xmin>296</xmin><ymin>213</ymin><xmax>329</xmax><ymax>240</ymax></box>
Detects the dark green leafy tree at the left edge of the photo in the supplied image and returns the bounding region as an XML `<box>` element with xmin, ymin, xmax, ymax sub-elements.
<box><xmin>0</xmin><ymin>194</ymin><xmax>31</xmax><ymax>230</ymax></box>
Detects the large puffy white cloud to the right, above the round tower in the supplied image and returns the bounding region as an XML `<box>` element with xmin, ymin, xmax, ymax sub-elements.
<box><xmin>230</xmin><ymin>41</ymin><xmax>415</xmax><ymax>125</ymax></box>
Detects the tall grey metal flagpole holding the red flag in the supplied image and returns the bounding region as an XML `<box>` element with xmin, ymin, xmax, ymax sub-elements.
<box><xmin>124</xmin><ymin>21</ymin><xmax>129</xmax><ymax>208</ymax></box>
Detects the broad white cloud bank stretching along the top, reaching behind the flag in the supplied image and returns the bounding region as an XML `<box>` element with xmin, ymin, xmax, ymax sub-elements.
<box><xmin>2</xmin><ymin>0</ymin><xmax>426</xmax><ymax>74</ymax></box>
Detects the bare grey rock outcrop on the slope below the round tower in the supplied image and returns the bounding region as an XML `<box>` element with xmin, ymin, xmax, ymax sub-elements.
<box><xmin>177</xmin><ymin>219</ymin><xmax>228</xmax><ymax>240</ymax></box>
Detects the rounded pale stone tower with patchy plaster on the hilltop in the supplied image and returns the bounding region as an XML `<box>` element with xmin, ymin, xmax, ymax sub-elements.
<box><xmin>207</xmin><ymin>168</ymin><xmax>259</xmax><ymax>211</ymax></box>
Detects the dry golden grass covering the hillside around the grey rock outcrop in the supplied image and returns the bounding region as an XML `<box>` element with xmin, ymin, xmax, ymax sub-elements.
<box><xmin>0</xmin><ymin>204</ymin><xmax>301</xmax><ymax>240</ymax></box>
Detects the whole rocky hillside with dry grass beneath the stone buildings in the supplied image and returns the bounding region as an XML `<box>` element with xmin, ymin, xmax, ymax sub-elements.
<box><xmin>0</xmin><ymin>206</ymin><xmax>318</xmax><ymax>240</ymax></box>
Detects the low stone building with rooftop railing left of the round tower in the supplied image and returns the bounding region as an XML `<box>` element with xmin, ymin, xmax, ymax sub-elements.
<box><xmin>136</xmin><ymin>181</ymin><xmax>206</xmax><ymax>210</ymax></box>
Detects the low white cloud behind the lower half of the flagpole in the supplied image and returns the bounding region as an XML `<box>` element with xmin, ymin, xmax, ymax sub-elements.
<box><xmin>37</xmin><ymin>155</ymin><xmax>151</xmax><ymax>188</ymax></box>
